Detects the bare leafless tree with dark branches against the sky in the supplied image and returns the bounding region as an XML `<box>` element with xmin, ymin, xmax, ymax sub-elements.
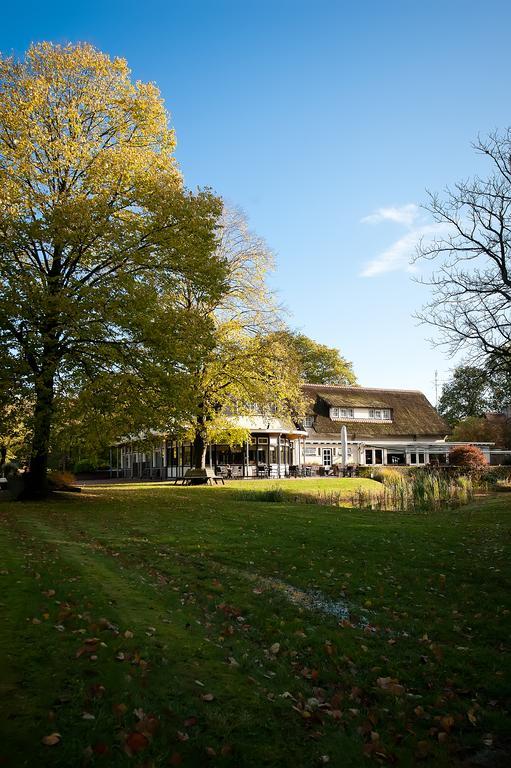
<box><xmin>418</xmin><ymin>128</ymin><xmax>511</xmax><ymax>374</ymax></box>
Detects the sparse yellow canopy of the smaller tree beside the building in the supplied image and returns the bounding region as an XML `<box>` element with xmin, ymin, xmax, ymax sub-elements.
<box><xmin>176</xmin><ymin>209</ymin><xmax>301</xmax><ymax>462</ymax></box>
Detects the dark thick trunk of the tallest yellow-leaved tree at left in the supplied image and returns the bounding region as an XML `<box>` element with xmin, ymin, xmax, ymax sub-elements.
<box><xmin>23</xmin><ymin>365</ymin><xmax>55</xmax><ymax>499</ymax></box>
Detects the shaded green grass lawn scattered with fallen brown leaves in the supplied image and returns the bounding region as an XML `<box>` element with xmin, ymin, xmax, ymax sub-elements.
<box><xmin>0</xmin><ymin>479</ymin><xmax>511</xmax><ymax>768</ymax></box>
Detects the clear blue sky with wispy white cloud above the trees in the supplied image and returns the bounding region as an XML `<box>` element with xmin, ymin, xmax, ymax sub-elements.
<box><xmin>0</xmin><ymin>0</ymin><xmax>511</xmax><ymax>397</ymax></box>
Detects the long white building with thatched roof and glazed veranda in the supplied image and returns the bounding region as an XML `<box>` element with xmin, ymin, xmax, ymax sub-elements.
<box><xmin>111</xmin><ymin>384</ymin><xmax>492</xmax><ymax>479</ymax></box>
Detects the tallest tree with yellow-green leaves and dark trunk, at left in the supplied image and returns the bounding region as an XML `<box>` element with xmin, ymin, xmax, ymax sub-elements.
<box><xmin>0</xmin><ymin>43</ymin><xmax>224</xmax><ymax>496</ymax></box>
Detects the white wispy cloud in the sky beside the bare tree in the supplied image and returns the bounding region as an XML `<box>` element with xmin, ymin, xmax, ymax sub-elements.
<box><xmin>361</xmin><ymin>203</ymin><xmax>445</xmax><ymax>277</ymax></box>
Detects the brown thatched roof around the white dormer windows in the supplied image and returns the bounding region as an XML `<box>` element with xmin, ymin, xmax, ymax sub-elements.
<box><xmin>303</xmin><ymin>384</ymin><xmax>449</xmax><ymax>440</ymax></box>
